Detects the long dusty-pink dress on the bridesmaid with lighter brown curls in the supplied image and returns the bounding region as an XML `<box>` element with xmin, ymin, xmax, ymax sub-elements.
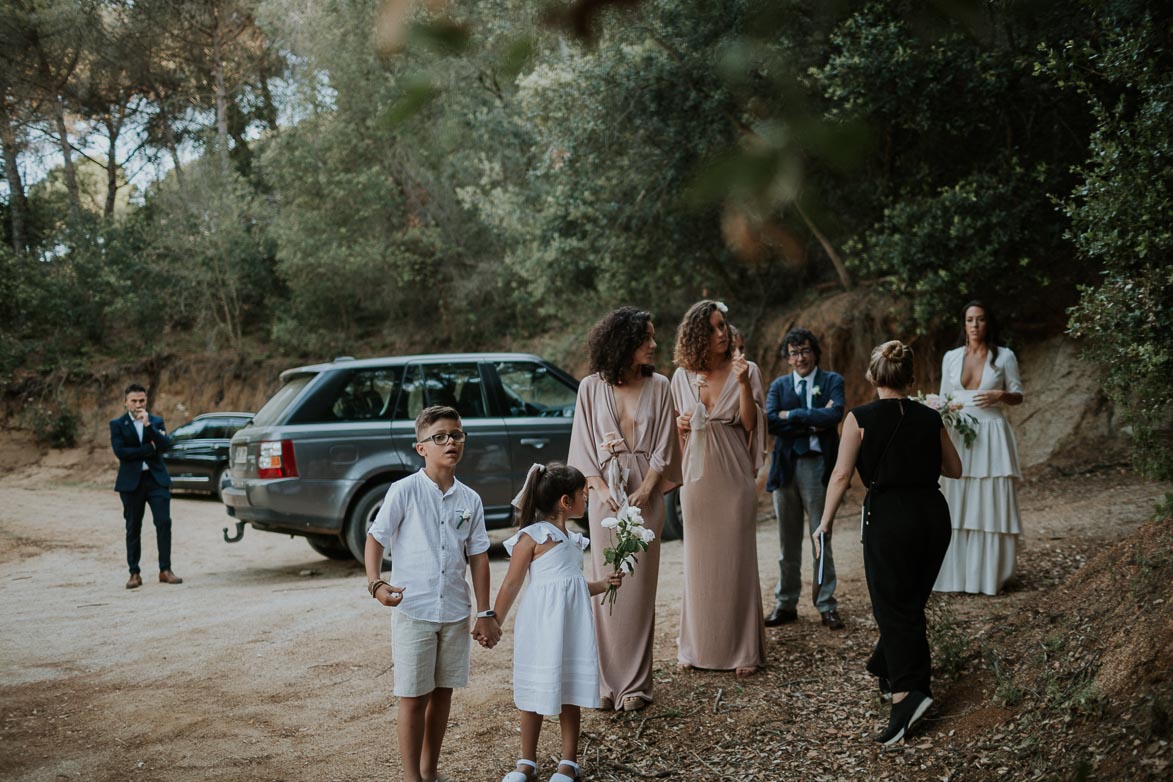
<box><xmin>672</xmin><ymin>361</ymin><xmax>766</xmax><ymax>671</ymax></box>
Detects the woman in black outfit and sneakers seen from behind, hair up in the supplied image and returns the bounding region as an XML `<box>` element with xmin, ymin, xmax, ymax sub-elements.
<box><xmin>813</xmin><ymin>340</ymin><xmax>961</xmax><ymax>744</ymax></box>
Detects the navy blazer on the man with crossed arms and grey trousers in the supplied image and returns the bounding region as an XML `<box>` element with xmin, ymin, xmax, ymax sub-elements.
<box><xmin>766</xmin><ymin>367</ymin><xmax>847</xmax><ymax>491</ymax></box>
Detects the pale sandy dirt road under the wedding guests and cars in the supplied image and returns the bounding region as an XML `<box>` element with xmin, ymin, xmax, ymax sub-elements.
<box><xmin>0</xmin><ymin>475</ymin><xmax>1167</xmax><ymax>782</ymax></box>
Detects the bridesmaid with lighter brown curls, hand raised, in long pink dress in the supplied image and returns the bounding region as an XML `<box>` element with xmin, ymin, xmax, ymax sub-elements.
<box><xmin>672</xmin><ymin>299</ymin><xmax>766</xmax><ymax>676</ymax></box>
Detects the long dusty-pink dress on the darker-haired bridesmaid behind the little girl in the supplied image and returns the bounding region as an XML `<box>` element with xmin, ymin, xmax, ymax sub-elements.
<box><xmin>567</xmin><ymin>374</ymin><xmax>680</xmax><ymax>709</ymax></box>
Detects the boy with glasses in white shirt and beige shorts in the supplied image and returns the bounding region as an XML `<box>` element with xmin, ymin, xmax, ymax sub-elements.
<box><xmin>365</xmin><ymin>406</ymin><xmax>501</xmax><ymax>782</ymax></box>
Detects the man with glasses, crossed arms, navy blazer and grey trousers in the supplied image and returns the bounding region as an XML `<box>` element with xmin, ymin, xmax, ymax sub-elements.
<box><xmin>766</xmin><ymin>328</ymin><xmax>847</xmax><ymax>630</ymax></box>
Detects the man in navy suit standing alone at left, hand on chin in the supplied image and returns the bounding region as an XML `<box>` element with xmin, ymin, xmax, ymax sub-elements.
<box><xmin>110</xmin><ymin>383</ymin><xmax>183</xmax><ymax>590</ymax></box>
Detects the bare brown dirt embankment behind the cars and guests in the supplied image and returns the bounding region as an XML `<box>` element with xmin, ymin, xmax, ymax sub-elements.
<box><xmin>0</xmin><ymin>288</ymin><xmax>1127</xmax><ymax>480</ymax></box>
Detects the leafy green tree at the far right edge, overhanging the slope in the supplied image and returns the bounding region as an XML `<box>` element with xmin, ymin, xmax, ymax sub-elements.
<box><xmin>1047</xmin><ymin>9</ymin><xmax>1173</xmax><ymax>480</ymax></box>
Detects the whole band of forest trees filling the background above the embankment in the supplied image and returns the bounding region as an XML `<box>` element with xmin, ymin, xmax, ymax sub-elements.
<box><xmin>0</xmin><ymin>0</ymin><xmax>1173</xmax><ymax>465</ymax></box>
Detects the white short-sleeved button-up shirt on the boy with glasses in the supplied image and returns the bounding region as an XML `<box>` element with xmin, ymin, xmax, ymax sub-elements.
<box><xmin>369</xmin><ymin>470</ymin><xmax>489</xmax><ymax>623</ymax></box>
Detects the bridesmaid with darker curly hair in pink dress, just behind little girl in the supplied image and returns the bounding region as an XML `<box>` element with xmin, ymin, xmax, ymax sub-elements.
<box><xmin>567</xmin><ymin>307</ymin><xmax>680</xmax><ymax>712</ymax></box>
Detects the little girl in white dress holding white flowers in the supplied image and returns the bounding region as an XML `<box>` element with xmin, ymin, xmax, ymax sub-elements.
<box><xmin>493</xmin><ymin>463</ymin><xmax>623</xmax><ymax>782</ymax></box>
